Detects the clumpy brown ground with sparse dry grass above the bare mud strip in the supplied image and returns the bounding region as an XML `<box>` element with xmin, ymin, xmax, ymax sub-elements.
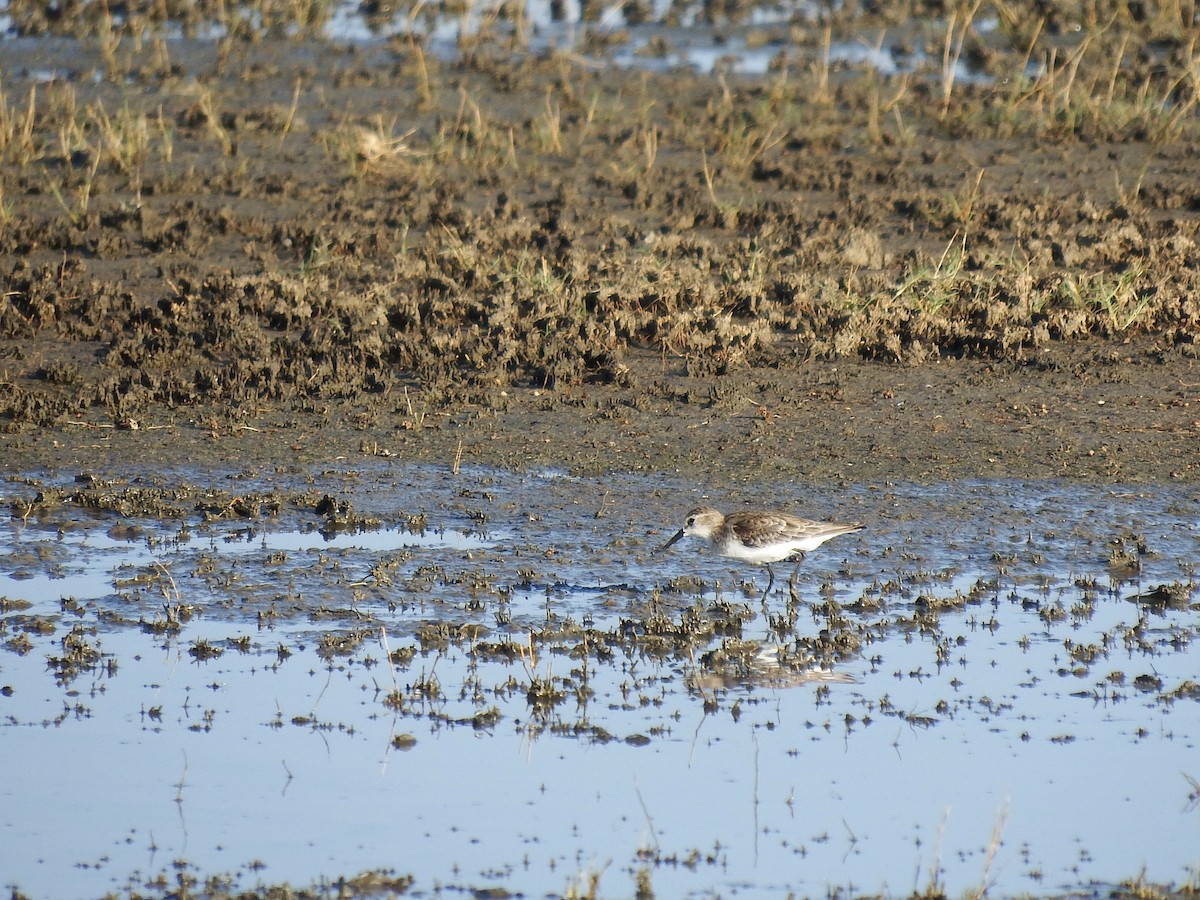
<box><xmin>0</xmin><ymin>2</ymin><xmax>1200</xmax><ymax>434</ymax></box>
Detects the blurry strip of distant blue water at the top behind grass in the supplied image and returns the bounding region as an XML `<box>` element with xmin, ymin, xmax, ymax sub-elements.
<box><xmin>0</xmin><ymin>0</ymin><xmax>993</xmax><ymax>83</ymax></box>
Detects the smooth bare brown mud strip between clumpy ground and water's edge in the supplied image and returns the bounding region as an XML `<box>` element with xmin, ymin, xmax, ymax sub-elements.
<box><xmin>0</xmin><ymin>347</ymin><xmax>1200</xmax><ymax>486</ymax></box>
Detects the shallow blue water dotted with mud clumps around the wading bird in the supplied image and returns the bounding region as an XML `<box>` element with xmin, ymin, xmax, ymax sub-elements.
<box><xmin>0</xmin><ymin>466</ymin><xmax>1200</xmax><ymax>896</ymax></box>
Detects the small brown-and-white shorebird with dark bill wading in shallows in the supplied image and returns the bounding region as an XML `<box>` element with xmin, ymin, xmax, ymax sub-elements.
<box><xmin>662</xmin><ymin>506</ymin><xmax>864</xmax><ymax>600</ymax></box>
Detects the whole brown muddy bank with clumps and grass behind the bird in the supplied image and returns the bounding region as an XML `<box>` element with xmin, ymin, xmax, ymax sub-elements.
<box><xmin>0</xmin><ymin>7</ymin><xmax>1200</xmax><ymax>484</ymax></box>
